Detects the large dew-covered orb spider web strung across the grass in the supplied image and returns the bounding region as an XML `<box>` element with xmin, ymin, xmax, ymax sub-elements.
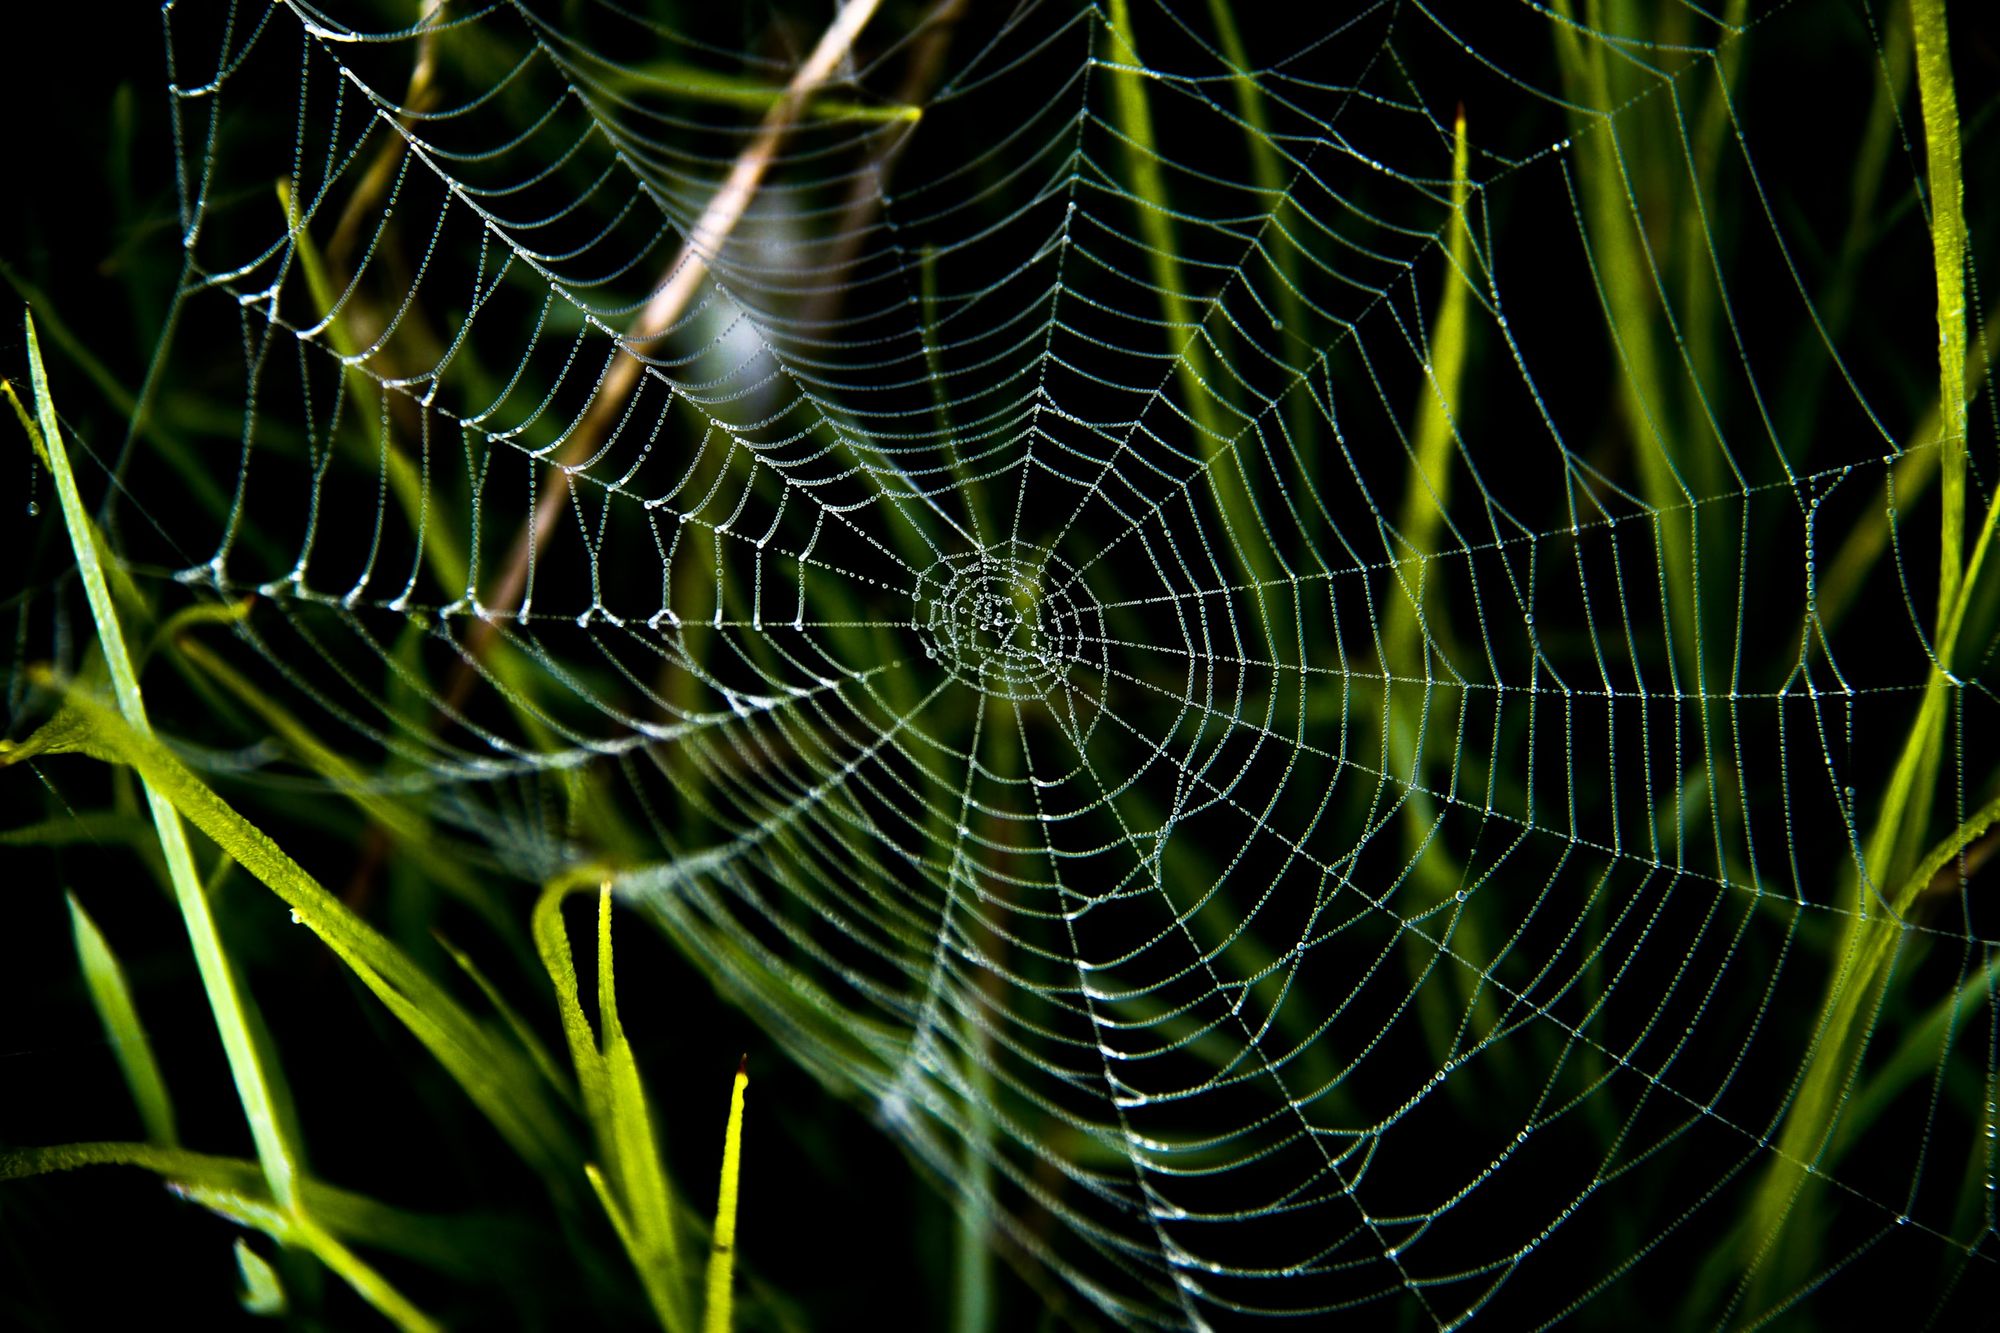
<box><xmin>132</xmin><ymin>0</ymin><xmax>2000</xmax><ymax>1327</ymax></box>
